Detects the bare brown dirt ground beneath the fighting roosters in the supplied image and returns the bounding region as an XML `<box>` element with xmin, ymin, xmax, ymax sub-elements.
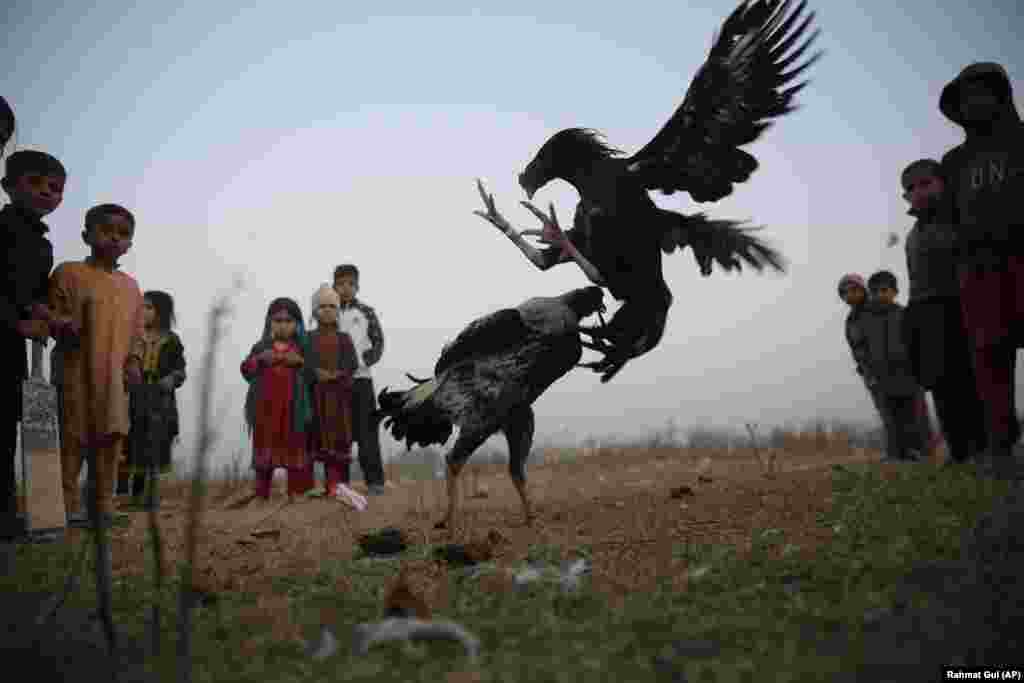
<box><xmin>90</xmin><ymin>447</ymin><xmax>879</xmax><ymax>598</ymax></box>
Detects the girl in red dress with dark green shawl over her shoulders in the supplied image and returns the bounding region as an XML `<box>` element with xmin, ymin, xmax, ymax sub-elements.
<box><xmin>242</xmin><ymin>298</ymin><xmax>313</xmax><ymax>503</ymax></box>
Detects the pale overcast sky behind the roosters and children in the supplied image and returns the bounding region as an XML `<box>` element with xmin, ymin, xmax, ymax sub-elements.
<box><xmin>0</xmin><ymin>0</ymin><xmax>1024</xmax><ymax>464</ymax></box>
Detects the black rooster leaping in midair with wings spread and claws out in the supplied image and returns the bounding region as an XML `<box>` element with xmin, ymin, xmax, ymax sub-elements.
<box><xmin>474</xmin><ymin>0</ymin><xmax>821</xmax><ymax>382</ymax></box>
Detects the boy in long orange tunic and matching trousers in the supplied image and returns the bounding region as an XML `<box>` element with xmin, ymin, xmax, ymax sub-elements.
<box><xmin>49</xmin><ymin>204</ymin><xmax>144</xmax><ymax>525</ymax></box>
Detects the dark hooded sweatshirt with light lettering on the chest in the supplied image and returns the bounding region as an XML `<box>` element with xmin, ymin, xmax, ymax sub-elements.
<box><xmin>939</xmin><ymin>61</ymin><xmax>1024</xmax><ymax>260</ymax></box>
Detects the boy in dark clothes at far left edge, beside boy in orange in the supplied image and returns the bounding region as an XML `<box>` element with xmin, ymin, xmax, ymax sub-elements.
<box><xmin>0</xmin><ymin>148</ymin><xmax>67</xmax><ymax>538</ymax></box>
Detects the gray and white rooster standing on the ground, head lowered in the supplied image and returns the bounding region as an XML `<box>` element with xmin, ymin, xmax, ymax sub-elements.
<box><xmin>377</xmin><ymin>287</ymin><xmax>604</xmax><ymax>528</ymax></box>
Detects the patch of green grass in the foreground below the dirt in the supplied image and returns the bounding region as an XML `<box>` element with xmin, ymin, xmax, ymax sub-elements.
<box><xmin>0</xmin><ymin>466</ymin><xmax>1005</xmax><ymax>683</ymax></box>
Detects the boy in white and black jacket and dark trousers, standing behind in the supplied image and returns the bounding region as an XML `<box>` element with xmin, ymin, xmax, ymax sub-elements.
<box><xmin>334</xmin><ymin>263</ymin><xmax>385</xmax><ymax>496</ymax></box>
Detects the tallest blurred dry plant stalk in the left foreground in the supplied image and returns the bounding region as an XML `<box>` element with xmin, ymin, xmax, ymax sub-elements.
<box><xmin>177</xmin><ymin>283</ymin><xmax>240</xmax><ymax>683</ymax></box>
